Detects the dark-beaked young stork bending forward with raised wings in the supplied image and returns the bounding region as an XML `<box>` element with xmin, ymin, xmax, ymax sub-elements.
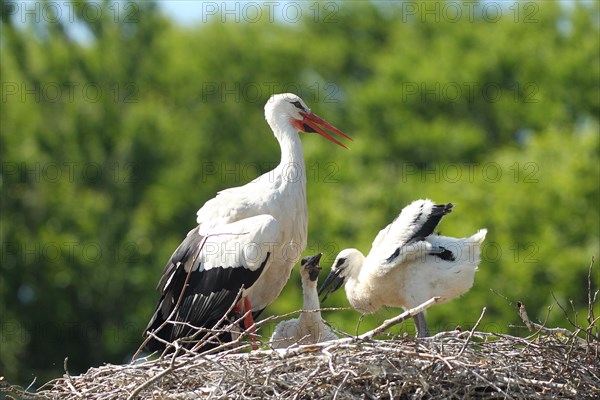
<box><xmin>319</xmin><ymin>200</ymin><xmax>487</xmax><ymax>337</ymax></box>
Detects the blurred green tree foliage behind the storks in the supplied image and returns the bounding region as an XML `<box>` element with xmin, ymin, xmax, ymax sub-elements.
<box><xmin>0</xmin><ymin>1</ymin><xmax>600</xmax><ymax>385</ymax></box>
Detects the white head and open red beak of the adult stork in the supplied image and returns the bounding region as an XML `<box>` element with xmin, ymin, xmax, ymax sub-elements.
<box><xmin>265</xmin><ymin>93</ymin><xmax>352</xmax><ymax>148</ymax></box>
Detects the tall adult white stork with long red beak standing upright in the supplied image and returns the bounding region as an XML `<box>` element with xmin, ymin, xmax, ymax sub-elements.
<box><xmin>146</xmin><ymin>93</ymin><xmax>351</xmax><ymax>351</ymax></box>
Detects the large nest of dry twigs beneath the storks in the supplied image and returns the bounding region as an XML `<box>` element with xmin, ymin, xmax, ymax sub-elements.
<box><xmin>22</xmin><ymin>314</ymin><xmax>600</xmax><ymax>400</ymax></box>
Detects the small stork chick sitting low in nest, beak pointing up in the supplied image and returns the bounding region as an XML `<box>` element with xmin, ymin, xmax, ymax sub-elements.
<box><xmin>271</xmin><ymin>253</ymin><xmax>338</xmax><ymax>349</ymax></box>
